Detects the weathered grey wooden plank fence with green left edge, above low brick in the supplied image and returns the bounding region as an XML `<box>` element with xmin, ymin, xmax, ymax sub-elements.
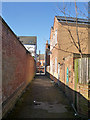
<box><xmin>75</xmin><ymin>58</ymin><xmax>90</xmax><ymax>84</ymax></box>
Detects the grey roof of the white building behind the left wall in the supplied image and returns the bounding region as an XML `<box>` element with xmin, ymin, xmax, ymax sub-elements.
<box><xmin>18</xmin><ymin>36</ymin><xmax>37</xmax><ymax>45</ymax></box>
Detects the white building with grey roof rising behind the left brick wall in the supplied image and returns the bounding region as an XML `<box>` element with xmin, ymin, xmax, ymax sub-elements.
<box><xmin>19</xmin><ymin>36</ymin><xmax>37</xmax><ymax>60</ymax></box>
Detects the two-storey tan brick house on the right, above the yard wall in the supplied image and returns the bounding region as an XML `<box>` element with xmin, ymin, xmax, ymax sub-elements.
<box><xmin>50</xmin><ymin>16</ymin><xmax>89</xmax><ymax>78</ymax></box>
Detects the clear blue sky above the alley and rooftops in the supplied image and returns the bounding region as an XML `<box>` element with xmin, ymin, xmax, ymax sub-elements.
<box><xmin>2</xmin><ymin>2</ymin><xmax>88</xmax><ymax>53</ymax></box>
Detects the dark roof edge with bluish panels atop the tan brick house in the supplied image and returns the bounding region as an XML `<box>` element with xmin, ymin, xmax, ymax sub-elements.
<box><xmin>56</xmin><ymin>16</ymin><xmax>90</xmax><ymax>25</ymax></box>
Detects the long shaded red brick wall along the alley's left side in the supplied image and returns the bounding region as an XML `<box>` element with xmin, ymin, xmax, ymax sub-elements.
<box><xmin>2</xmin><ymin>17</ymin><xmax>35</xmax><ymax>117</ymax></box>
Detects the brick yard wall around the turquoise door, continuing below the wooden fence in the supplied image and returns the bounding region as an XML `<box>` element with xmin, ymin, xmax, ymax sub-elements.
<box><xmin>65</xmin><ymin>55</ymin><xmax>88</xmax><ymax>116</ymax></box>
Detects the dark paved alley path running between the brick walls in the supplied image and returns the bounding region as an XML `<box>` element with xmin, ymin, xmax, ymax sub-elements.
<box><xmin>7</xmin><ymin>75</ymin><xmax>74</xmax><ymax>119</ymax></box>
